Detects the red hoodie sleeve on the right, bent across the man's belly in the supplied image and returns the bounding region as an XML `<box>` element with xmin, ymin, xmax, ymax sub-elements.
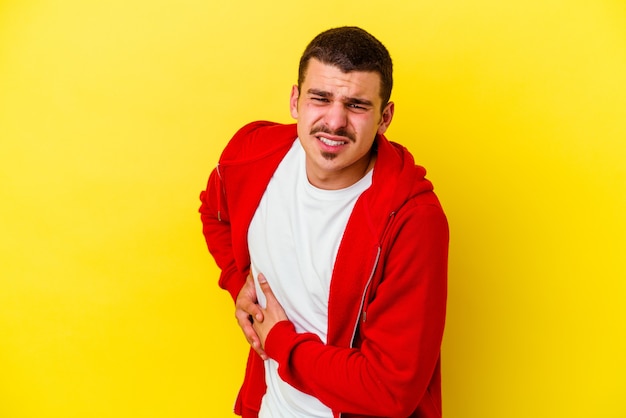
<box><xmin>265</xmin><ymin>204</ymin><xmax>448</xmax><ymax>418</ymax></box>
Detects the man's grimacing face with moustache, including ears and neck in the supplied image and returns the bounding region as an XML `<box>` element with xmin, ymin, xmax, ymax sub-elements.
<box><xmin>290</xmin><ymin>59</ymin><xmax>394</xmax><ymax>189</ymax></box>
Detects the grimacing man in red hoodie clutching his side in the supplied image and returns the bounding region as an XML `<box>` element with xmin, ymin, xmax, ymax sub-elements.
<box><xmin>200</xmin><ymin>27</ymin><xmax>448</xmax><ymax>418</ymax></box>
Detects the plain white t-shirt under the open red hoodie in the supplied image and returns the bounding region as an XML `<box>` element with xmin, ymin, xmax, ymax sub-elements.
<box><xmin>248</xmin><ymin>140</ymin><xmax>372</xmax><ymax>418</ymax></box>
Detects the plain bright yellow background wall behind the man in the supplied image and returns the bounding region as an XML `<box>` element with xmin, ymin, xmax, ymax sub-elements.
<box><xmin>0</xmin><ymin>0</ymin><xmax>626</xmax><ymax>418</ymax></box>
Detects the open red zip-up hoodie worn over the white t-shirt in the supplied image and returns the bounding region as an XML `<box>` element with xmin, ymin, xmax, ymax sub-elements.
<box><xmin>200</xmin><ymin>122</ymin><xmax>448</xmax><ymax>418</ymax></box>
